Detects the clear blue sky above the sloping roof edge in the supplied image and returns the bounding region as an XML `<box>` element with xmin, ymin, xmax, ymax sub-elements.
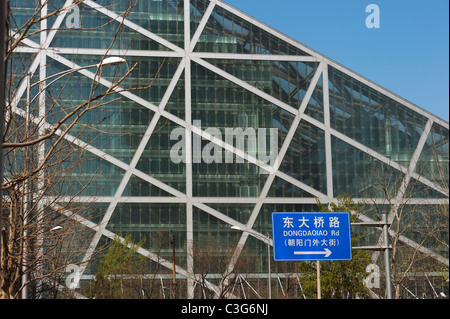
<box><xmin>224</xmin><ymin>0</ymin><xmax>449</xmax><ymax>121</ymax></box>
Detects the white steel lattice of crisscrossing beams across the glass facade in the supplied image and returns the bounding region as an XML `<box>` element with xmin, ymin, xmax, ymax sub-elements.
<box><xmin>11</xmin><ymin>0</ymin><xmax>449</xmax><ymax>297</ymax></box>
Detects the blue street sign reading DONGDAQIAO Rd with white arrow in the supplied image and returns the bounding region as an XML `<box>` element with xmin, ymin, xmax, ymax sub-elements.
<box><xmin>272</xmin><ymin>212</ymin><xmax>352</xmax><ymax>261</ymax></box>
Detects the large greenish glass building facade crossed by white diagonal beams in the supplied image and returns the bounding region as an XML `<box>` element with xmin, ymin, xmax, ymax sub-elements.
<box><xmin>11</xmin><ymin>0</ymin><xmax>449</xmax><ymax>298</ymax></box>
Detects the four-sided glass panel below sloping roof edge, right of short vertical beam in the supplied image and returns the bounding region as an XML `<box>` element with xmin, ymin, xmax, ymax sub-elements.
<box><xmin>329</xmin><ymin>66</ymin><xmax>427</xmax><ymax>167</ymax></box>
